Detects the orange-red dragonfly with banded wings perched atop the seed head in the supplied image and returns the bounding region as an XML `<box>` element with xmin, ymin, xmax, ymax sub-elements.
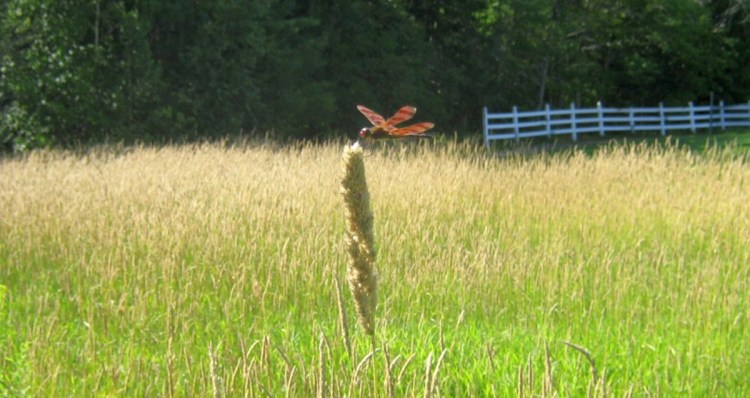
<box><xmin>357</xmin><ymin>105</ymin><xmax>434</xmax><ymax>140</ymax></box>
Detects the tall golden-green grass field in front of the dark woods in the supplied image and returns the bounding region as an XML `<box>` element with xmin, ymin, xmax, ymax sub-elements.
<box><xmin>0</xmin><ymin>133</ymin><xmax>750</xmax><ymax>397</ymax></box>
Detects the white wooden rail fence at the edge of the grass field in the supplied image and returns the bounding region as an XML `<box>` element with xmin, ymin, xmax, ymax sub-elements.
<box><xmin>484</xmin><ymin>101</ymin><xmax>750</xmax><ymax>147</ymax></box>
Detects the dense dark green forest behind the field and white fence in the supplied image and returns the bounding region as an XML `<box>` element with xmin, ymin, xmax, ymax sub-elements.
<box><xmin>0</xmin><ymin>0</ymin><xmax>750</xmax><ymax>149</ymax></box>
